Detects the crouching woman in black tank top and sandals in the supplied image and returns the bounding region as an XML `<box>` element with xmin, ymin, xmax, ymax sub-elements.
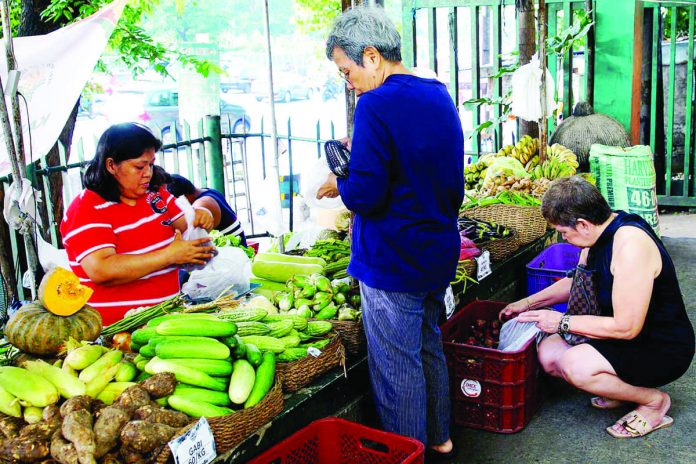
<box><xmin>501</xmin><ymin>177</ymin><xmax>694</xmax><ymax>438</ymax></box>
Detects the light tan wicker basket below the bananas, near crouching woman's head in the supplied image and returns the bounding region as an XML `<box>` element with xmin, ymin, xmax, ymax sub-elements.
<box><xmin>462</xmin><ymin>203</ymin><xmax>547</xmax><ymax>245</ymax></box>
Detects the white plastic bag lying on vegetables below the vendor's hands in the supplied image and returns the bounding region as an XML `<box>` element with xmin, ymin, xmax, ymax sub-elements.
<box><xmin>181</xmin><ymin>247</ymin><xmax>251</xmax><ymax>300</ymax></box>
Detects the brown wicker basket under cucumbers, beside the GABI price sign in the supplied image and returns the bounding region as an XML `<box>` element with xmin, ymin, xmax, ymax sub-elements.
<box><xmin>153</xmin><ymin>376</ymin><xmax>283</xmax><ymax>464</ymax></box>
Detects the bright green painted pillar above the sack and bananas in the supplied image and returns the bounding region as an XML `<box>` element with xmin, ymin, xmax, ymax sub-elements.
<box><xmin>594</xmin><ymin>0</ymin><xmax>636</xmax><ymax>132</ymax></box>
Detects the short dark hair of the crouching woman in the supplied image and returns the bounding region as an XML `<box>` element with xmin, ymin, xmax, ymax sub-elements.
<box><xmin>541</xmin><ymin>176</ymin><xmax>611</xmax><ymax>227</ymax></box>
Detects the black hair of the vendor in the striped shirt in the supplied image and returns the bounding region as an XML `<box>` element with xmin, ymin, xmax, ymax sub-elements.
<box><xmin>85</xmin><ymin>122</ymin><xmax>164</xmax><ymax>202</ymax></box>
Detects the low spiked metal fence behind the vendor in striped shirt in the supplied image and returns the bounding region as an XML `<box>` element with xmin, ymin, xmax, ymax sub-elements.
<box><xmin>0</xmin><ymin>117</ymin><xmax>335</xmax><ymax>300</ymax></box>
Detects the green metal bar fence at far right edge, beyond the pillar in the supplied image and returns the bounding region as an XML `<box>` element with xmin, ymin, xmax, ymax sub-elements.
<box><xmin>641</xmin><ymin>0</ymin><xmax>696</xmax><ymax>208</ymax></box>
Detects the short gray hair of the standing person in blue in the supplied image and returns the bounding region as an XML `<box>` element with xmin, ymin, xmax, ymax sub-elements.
<box><xmin>326</xmin><ymin>6</ymin><xmax>401</xmax><ymax>66</ymax></box>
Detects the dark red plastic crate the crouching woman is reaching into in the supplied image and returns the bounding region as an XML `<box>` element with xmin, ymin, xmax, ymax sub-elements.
<box><xmin>440</xmin><ymin>301</ymin><xmax>541</xmax><ymax>433</ymax></box>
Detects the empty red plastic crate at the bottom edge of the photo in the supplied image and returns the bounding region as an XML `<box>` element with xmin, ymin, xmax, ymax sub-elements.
<box><xmin>249</xmin><ymin>417</ymin><xmax>424</xmax><ymax>464</ymax></box>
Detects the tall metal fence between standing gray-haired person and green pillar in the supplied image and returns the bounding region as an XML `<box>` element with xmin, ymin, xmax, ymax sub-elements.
<box><xmin>402</xmin><ymin>0</ymin><xmax>588</xmax><ymax>155</ymax></box>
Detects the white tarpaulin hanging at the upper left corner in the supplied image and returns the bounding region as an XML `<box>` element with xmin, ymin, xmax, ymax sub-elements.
<box><xmin>0</xmin><ymin>0</ymin><xmax>127</xmax><ymax>175</ymax></box>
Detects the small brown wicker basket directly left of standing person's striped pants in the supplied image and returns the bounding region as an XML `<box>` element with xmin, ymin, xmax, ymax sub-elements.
<box><xmin>276</xmin><ymin>334</ymin><xmax>346</xmax><ymax>393</ymax></box>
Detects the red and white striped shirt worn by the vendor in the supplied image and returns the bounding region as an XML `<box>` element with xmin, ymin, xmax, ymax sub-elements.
<box><xmin>60</xmin><ymin>188</ymin><xmax>184</xmax><ymax>325</ymax></box>
